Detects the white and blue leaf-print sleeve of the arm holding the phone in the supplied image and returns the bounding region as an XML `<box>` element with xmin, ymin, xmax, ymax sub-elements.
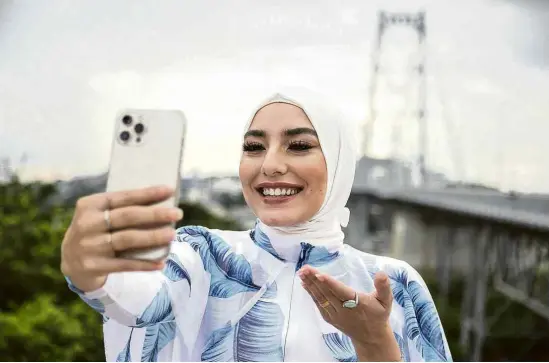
<box><xmin>63</xmin><ymin>233</ymin><xmax>210</xmax><ymax>362</ymax></box>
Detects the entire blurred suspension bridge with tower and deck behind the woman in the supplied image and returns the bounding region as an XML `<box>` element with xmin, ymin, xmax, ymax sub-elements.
<box><xmin>346</xmin><ymin>11</ymin><xmax>549</xmax><ymax>361</ymax></box>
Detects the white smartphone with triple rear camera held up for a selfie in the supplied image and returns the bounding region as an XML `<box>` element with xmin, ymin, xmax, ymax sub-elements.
<box><xmin>107</xmin><ymin>109</ymin><xmax>187</xmax><ymax>261</ymax></box>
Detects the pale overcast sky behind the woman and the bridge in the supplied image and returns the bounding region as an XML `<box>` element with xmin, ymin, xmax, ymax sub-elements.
<box><xmin>0</xmin><ymin>0</ymin><xmax>549</xmax><ymax>192</ymax></box>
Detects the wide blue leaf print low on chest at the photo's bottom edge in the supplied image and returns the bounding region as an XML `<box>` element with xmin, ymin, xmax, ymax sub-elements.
<box><xmin>202</xmin><ymin>300</ymin><xmax>284</xmax><ymax>362</ymax></box>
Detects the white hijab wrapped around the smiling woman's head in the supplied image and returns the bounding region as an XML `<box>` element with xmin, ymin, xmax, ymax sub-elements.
<box><xmin>245</xmin><ymin>88</ymin><xmax>356</xmax><ymax>245</ymax></box>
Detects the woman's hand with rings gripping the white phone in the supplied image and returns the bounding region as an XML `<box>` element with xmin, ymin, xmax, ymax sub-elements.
<box><xmin>61</xmin><ymin>187</ymin><xmax>183</xmax><ymax>292</ymax></box>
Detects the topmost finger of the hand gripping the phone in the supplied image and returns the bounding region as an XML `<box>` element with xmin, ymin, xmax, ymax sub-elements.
<box><xmin>103</xmin><ymin>186</ymin><xmax>174</xmax><ymax>209</ymax></box>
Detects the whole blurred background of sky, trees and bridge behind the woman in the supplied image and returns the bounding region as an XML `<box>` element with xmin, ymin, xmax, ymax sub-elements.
<box><xmin>0</xmin><ymin>0</ymin><xmax>549</xmax><ymax>361</ymax></box>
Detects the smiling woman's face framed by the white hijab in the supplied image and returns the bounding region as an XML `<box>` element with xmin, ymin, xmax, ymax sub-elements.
<box><xmin>239</xmin><ymin>103</ymin><xmax>327</xmax><ymax>227</ymax></box>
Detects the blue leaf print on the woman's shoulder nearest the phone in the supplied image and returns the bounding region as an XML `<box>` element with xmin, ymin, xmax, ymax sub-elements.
<box><xmin>179</xmin><ymin>227</ymin><xmax>260</xmax><ymax>298</ymax></box>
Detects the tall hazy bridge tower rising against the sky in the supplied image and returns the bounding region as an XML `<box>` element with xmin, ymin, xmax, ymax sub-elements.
<box><xmin>362</xmin><ymin>11</ymin><xmax>427</xmax><ymax>186</ymax></box>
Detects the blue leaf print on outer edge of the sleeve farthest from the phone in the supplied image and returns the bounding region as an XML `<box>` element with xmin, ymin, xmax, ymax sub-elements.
<box><xmin>384</xmin><ymin>269</ymin><xmax>446</xmax><ymax>362</ymax></box>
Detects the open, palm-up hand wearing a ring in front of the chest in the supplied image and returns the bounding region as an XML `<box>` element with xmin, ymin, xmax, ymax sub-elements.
<box><xmin>299</xmin><ymin>266</ymin><xmax>401</xmax><ymax>362</ymax></box>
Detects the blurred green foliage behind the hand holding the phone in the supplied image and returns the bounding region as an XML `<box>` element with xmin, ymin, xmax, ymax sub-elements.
<box><xmin>0</xmin><ymin>176</ymin><xmax>239</xmax><ymax>361</ymax></box>
